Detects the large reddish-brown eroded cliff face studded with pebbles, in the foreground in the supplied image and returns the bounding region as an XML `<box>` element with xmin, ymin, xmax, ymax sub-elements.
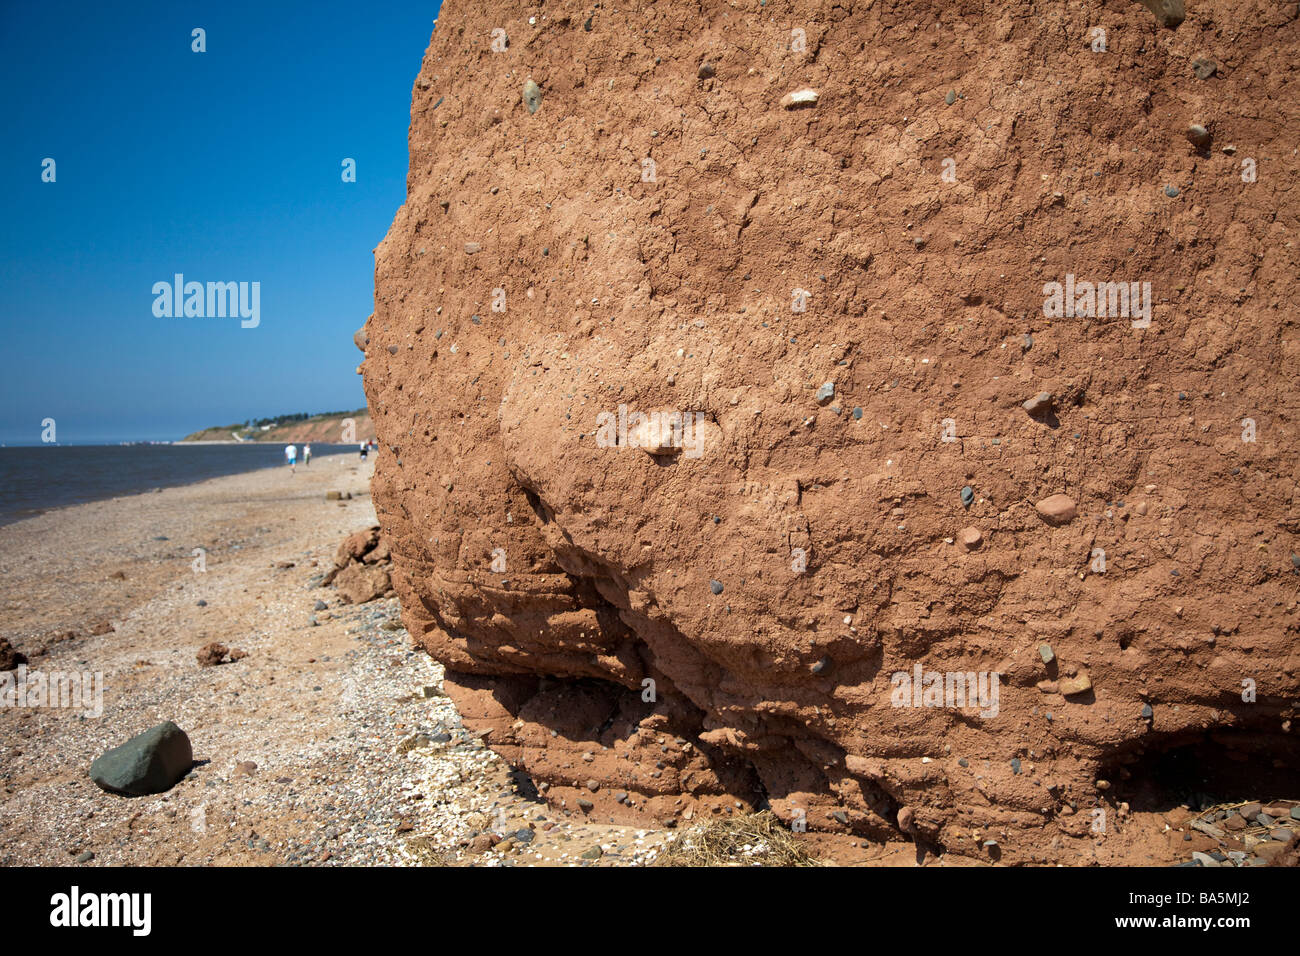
<box><xmin>361</xmin><ymin>0</ymin><xmax>1300</xmax><ymax>861</ymax></box>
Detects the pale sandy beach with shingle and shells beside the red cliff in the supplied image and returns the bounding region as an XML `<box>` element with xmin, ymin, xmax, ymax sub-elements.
<box><xmin>0</xmin><ymin>455</ymin><xmax>691</xmax><ymax>865</ymax></box>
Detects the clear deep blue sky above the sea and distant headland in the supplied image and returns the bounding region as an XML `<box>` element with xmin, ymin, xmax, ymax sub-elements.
<box><xmin>0</xmin><ymin>0</ymin><xmax>438</xmax><ymax>444</ymax></box>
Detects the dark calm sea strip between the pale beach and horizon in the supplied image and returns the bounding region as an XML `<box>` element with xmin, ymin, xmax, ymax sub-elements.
<box><xmin>0</xmin><ymin>442</ymin><xmax>356</xmax><ymax>524</ymax></box>
